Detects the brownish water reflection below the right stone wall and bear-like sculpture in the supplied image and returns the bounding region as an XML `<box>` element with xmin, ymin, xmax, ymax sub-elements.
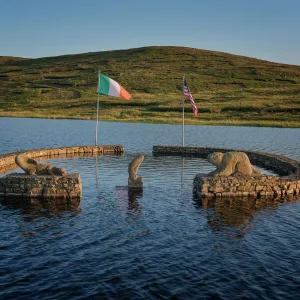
<box><xmin>194</xmin><ymin>197</ymin><xmax>295</xmax><ymax>237</ymax></box>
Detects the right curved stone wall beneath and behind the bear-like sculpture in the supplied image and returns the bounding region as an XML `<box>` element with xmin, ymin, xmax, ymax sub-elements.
<box><xmin>153</xmin><ymin>146</ymin><xmax>300</xmax><ymax>198</ymax></box>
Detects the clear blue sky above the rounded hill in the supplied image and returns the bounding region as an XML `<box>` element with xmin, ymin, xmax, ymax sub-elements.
<box><xmin>0</xmin><ymin>0</ymin><xmax>300</xmax><ymax>65</ymax></box>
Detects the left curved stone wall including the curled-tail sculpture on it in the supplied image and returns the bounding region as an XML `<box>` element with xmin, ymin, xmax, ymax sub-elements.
<box><xmin>0</xmin><ymin>145</ymin><xmax>124</xmax><ymax>204</ymax></box>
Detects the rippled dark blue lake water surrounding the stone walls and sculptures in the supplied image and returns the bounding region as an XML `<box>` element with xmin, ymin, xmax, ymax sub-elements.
<box><xmin>0</xmin><ymin>118</ymin><xmax>300</xmax><ymax>299</ymax></box>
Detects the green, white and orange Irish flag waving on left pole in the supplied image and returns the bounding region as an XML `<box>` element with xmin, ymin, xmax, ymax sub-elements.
<box><xmin>97</xmin><ymin>74</ymin><xmax>131</xmax><ymax>100</ymax></box>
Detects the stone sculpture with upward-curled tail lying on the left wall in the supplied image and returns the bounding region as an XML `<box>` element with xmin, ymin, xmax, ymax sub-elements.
<box><xmin>15</xmin><ymin>154</ymin><xmax>67</xmax><ymax>176</ymax></box>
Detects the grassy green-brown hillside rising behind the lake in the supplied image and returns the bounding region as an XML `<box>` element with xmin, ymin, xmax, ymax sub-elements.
<box><xmin>0</xmin><ymin>47</ymin><xmax>300</xmax><ymax>127</ymax></box>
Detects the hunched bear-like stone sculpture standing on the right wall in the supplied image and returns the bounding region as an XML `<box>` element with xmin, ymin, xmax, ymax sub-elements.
<box><xmin>207</xmin><ymin>152</ymin><xmax>262</xmax><ymax>176</ymax></box>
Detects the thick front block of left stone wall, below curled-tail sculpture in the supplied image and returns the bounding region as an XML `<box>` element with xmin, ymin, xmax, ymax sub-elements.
<box><xmin>0</xmin><ymin>173</ymin><xmax>82</xmax><ymax>204</ymax></box>
